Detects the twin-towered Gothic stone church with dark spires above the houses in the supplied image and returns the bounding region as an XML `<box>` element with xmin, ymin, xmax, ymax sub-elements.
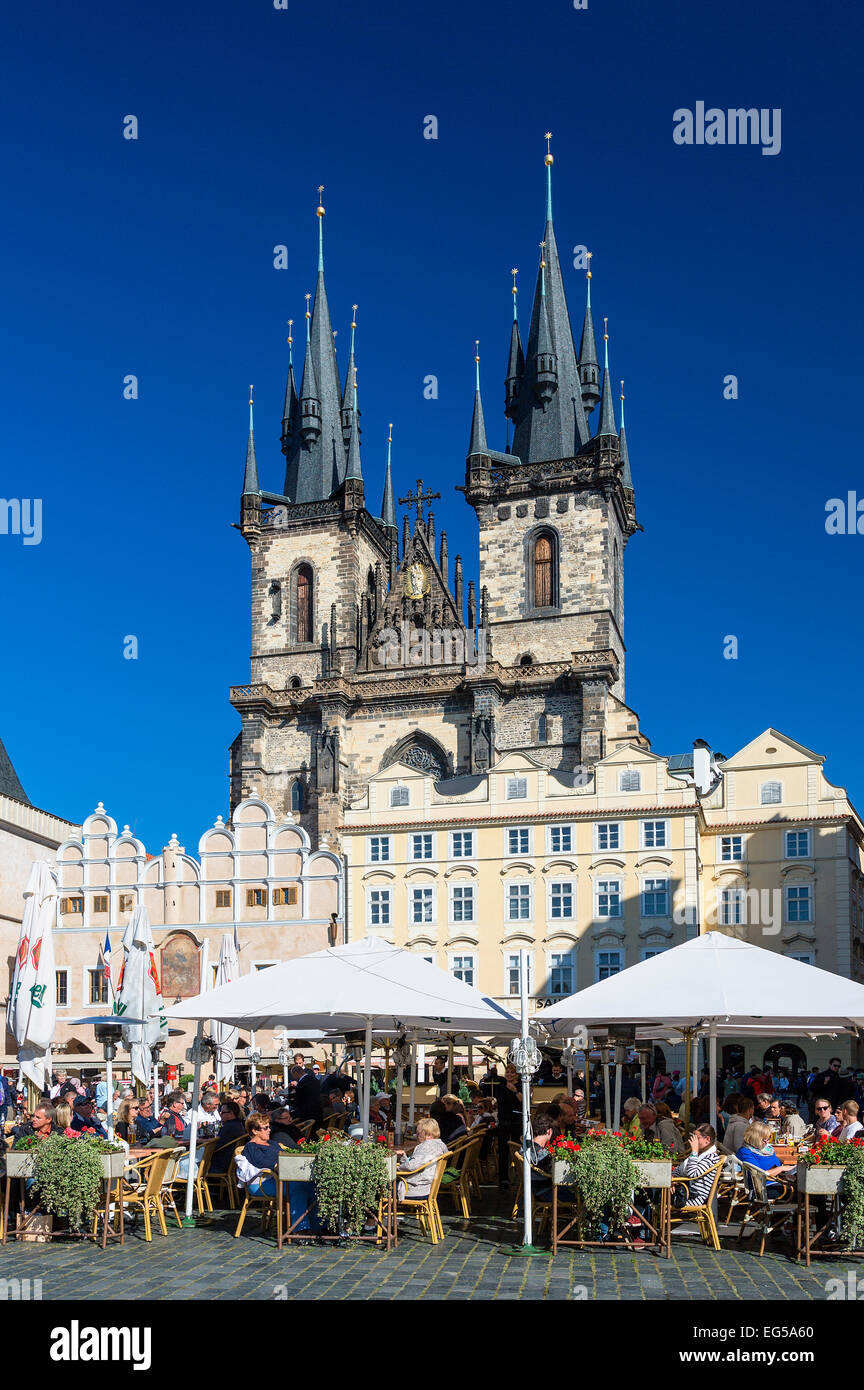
<box><xmin>231</xmin><ymin>154</ymin><xmax>647</xmax><ymax>840</ymax></box>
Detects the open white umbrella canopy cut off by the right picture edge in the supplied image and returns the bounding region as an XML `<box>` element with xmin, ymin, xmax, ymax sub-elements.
<box><xmin>535</xmin><ymin>931</ymin><xmax>864</xmax><ymax>1037</ymax></box>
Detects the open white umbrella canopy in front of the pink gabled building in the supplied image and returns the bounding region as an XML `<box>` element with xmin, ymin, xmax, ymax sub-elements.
<box><xmin>168</xmin><ymin>938</ymin><xmax>520</xmax><ymax>1036</ymax></box>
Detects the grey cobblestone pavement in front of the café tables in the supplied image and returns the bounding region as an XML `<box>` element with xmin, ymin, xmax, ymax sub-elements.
<box><xmin>0</xmin><ymin>1191</ymin><xmax>861</xmax><ymax>1301</ymax></box>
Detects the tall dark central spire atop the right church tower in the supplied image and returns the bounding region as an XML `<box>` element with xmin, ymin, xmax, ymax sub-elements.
<box><xmin>508</xmin><ymin>133</ymin><xmax>589</xmax><ymax>463</ymax></box>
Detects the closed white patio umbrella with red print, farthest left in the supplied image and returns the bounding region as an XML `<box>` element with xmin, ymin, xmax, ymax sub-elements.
<box><xmin>6</xmin><ymin>859</ymin><xmax>57</xmax><ymax>1091</ymax></box>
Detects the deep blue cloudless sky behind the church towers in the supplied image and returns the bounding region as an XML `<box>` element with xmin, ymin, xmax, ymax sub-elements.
<box><xmin>0</xmin><ymin>0</ymin><xmax>864</xmax><ymax>851</ymax></box>
